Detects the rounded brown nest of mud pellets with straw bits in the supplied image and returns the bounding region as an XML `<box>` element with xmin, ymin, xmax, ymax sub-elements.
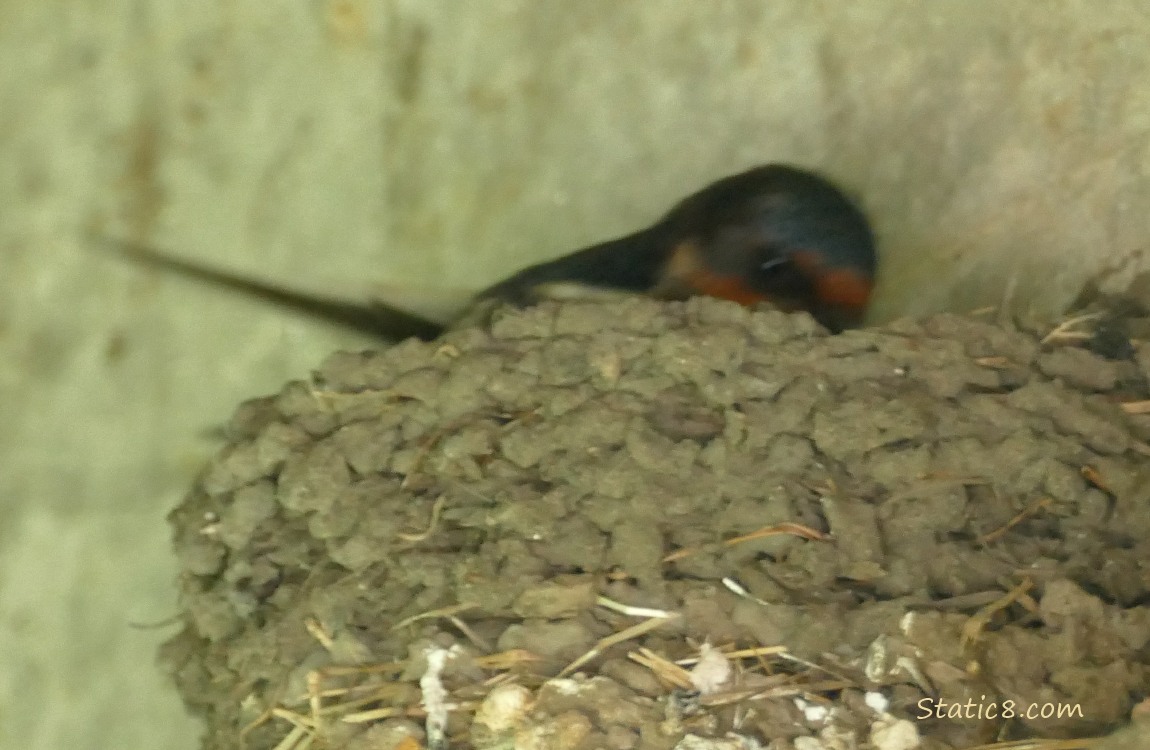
<box><xmin>163</xmin><ymin>299</ymin><xmax>1150</xmax><ymax>750</ymax></box>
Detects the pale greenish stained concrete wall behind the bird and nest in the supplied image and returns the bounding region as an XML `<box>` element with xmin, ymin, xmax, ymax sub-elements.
<box><xmin>0</xmin><ymin>0</ymin><xmax>1150</xmax><ymax>750</ymax></box>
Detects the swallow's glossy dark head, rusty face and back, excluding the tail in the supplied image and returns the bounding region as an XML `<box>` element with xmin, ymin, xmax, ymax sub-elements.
<box><xmin>480</xmin><ymin>164</ymin><xmax>877</xmax><ymax>332</ymax></box>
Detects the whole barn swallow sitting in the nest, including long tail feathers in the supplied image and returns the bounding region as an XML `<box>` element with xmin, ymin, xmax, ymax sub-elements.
<box><xmin>98</xmin><ymin>164</ymin><xmax>877</xmax><ymax>340</ymax></box>
